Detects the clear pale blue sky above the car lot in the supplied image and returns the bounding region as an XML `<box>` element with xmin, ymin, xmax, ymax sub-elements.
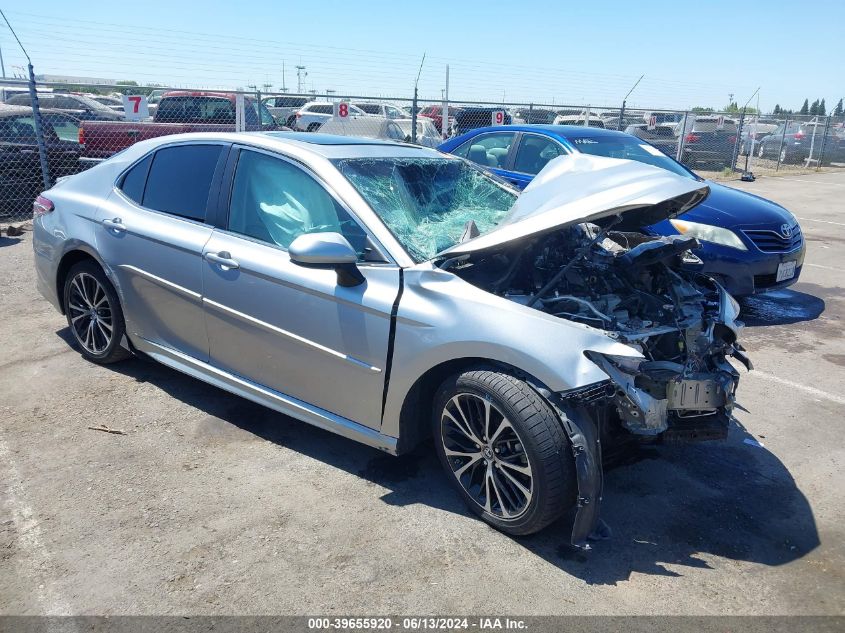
<box><xmin>0</xmin><ymin>0</ymin><xmax>845</xmax><ymax>110</ymax></box>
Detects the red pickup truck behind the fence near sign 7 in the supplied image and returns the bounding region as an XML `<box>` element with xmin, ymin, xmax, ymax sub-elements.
<box><xmin>79</xmin><ymin>90</ymin><xmax>278</xmax><ymax>160</ymax></box>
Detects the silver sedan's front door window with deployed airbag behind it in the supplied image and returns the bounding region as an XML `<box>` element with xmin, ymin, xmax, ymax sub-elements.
<box><xmin>228</xmin><ymin>150</ymin><xmax>367</xmax><ymax>256</ymax></box>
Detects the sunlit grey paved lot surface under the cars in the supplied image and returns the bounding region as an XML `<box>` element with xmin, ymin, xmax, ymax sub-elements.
<box><xmin>0</xmin><ymin>173</ymin><xmax>845</xmax><ymax>615</ymax></box>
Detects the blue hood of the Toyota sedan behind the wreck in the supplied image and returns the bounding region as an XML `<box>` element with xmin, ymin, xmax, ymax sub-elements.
<box><xmin>681</xmin><ymin>181</ymin><xmax>796</xmax><ymax>229</ymax></box>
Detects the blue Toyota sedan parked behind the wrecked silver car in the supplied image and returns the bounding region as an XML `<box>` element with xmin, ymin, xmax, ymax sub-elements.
<box><xmin>438</xmin><ymin>125</ymin><xmax>805</xmax><ymax>296</ymax></box>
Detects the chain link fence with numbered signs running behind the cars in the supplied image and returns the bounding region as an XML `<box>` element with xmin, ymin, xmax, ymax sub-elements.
<box><xmin>0</xmin><ymin>82</ymin><xmax>845</xmax><ymax>223</ymax></box>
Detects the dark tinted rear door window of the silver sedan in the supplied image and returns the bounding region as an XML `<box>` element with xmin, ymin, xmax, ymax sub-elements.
<box><xmin>142</xmin><ymin>145</ymin><xmax>223</xmax><ymax>221</ymax></box>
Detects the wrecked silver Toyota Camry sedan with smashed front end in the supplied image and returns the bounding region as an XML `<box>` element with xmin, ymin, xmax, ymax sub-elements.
<box><xmin>34</xmin><ymin>133</ymin><xmax>750</xmax><ymax>547</ymax></box>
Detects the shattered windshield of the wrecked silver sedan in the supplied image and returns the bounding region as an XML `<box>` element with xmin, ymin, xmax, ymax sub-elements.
<box><xmin>335</xmin><ymin>158</ymin><xmax>517</xmax><ymax>263</ymax></box>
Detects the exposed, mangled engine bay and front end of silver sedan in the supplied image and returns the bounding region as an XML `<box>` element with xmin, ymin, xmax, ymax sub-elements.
<box><xmin>444</xmin><ymin>222</ymin><xmax>751</xmax><ymax>441</ymax></box>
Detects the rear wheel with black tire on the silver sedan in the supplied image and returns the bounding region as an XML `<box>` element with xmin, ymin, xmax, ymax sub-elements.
<box><xmin>63</xmin><ymin>261</ymin><xmax>131</xmax><ymax>365</ymax></box>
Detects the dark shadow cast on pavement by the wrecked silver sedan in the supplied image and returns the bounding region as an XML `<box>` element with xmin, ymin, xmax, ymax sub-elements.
<box><xmin>72</xmin><ymin>330</ymin><xmax>819</xmax><ymax>584</ymax></box>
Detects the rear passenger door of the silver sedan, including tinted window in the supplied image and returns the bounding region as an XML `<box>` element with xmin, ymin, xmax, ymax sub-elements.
<box><xmin>97</xmin><ymin>142</ymin><xmax>229</xmax><ymax>361</ymax></box>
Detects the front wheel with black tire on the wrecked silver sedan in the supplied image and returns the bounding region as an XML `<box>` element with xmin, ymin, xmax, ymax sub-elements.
<box><xmin>432</xmin><ymin>368</ymin><xmax>576</xmax><ymax>535</ymax></box>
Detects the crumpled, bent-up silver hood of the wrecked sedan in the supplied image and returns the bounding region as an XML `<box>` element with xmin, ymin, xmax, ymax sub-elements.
<box><xmin>440</xmin><ymin>154</ymin><xmax>709</xmax><ymax>256</ymax></box>
